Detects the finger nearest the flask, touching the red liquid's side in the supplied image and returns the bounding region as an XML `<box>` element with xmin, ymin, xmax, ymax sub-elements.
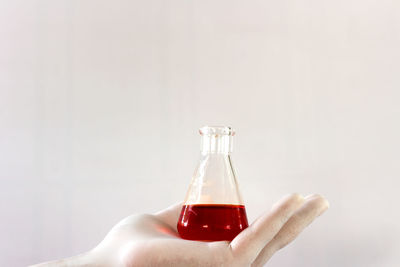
<box><xmin>230</xmin><ymin>194</ymin><xmax>304</xmax><ymax>263</ymax></box>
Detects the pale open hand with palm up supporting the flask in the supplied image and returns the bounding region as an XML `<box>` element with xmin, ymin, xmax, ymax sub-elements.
<box><xmin>35</xmin><ymin>194</ymin><xmax>329</xmax><ymax>267</ymax></box>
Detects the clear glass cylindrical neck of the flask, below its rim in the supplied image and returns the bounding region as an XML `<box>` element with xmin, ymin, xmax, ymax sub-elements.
<box><xmin>200</xmin><ymin>134</ymin><xmax>233</xmax><ymax>155</ymax></box>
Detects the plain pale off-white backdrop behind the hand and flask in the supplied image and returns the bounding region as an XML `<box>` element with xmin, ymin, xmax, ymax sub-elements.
<box><xmin>0</xmin><ymin>0</ymin><xmax>400</xmax><ymax>267</ymax></box>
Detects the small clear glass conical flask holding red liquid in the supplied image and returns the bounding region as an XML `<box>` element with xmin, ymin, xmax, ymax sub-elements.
<box><xmin>177</xmin><ymin>126</ymin><xmax>248</xmax><ymax>241</ymax></box>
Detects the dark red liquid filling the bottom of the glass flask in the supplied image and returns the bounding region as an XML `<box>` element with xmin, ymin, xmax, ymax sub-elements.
<box><xmin>177</xmin><ymin>204</ymin><xmax>249</xmax><ymax>241</ymax></box>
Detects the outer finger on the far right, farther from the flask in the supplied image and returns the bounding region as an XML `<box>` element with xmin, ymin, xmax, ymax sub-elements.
<box><xmin>252</xmin><ymin>195</ymin><xmax>329</xmax><ymax>266</ymax></box>
